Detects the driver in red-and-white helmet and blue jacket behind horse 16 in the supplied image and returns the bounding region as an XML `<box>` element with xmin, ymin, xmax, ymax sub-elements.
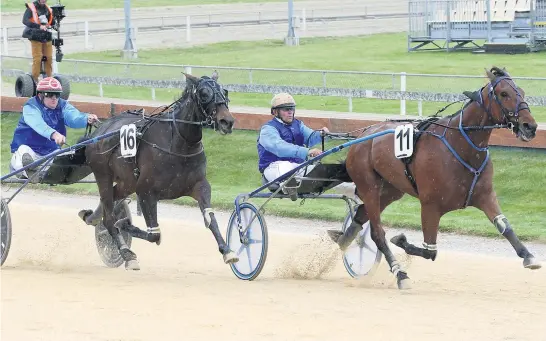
<box><xmin>10</xmin><ymin>77</ymin><xmax>98</xmax><ymax>181</ymax></box>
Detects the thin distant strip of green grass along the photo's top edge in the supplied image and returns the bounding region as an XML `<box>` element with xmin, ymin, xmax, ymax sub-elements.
<box><xmin>1</xmin><ymin>0</ymin><xmax>282</xmax><ymax>12</ymax></box>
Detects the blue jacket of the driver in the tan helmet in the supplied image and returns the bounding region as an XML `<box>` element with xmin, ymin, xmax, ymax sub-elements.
<box><xmin>257</xmin><ymin>118</ymin><xmax>321</xmax><ymax>173</ymax></box>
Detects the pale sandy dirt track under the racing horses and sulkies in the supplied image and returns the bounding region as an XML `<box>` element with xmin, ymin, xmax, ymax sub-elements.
<box><xmin>1</xmin><ymin>191</ymin><xmax>546</xmax><ymax>341</ymax></box>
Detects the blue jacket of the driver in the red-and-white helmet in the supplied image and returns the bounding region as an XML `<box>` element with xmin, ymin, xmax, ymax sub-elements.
<box><xmin>11</xmin><ymin>96</ymin><xmax>87</xmax><ymax>155</ymax></box>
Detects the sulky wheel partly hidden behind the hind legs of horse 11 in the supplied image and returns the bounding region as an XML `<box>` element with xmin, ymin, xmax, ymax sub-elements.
<box><xmin>342</xmin><ymin>212</ymin><xmax>381</xmax><ymax>278</ymax></box>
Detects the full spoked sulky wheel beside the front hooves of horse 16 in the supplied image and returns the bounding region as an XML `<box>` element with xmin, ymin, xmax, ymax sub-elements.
<box><xmin>227</xmin><ymin>203</ymin><xmax>268</xmax><ymax>281</ymax></box>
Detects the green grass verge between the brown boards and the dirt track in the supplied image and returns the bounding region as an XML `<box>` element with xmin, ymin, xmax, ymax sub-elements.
<box><xmin>0</xmin><ymin>110</ymin><xmax>546</xmax><ymax>242</ymax></box>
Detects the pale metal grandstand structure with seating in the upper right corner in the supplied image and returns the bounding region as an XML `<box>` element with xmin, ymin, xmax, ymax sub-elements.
<box><xmin>408</xmin><ymin>0</ymin><xmax>546</xmax><ymax>53</ymax></box>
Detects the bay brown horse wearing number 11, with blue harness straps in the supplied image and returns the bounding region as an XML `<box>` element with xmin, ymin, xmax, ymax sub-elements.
<box><xmin>329</xmin><ymin>67</ymin><xmax>541</xmax><ymax>289</ymax></box>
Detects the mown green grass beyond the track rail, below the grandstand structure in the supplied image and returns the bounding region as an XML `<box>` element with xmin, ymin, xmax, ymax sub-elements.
<box><xmin>4</xmin><ymin>34</ymin><xmax>546</xmax><ymax>122</ymax></box>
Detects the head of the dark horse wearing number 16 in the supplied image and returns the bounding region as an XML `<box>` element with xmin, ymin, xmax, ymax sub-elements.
<box><xmin>184</xmin><ymin>71</ymin><xmax>235</xmax><ymax>134</ymax></box>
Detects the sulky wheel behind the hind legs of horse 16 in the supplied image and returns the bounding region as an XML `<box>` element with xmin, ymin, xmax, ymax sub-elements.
<box><xmin>95</xmin><ymin>200</ymin><xmax>133</xmax><ymax>268</ymax></box>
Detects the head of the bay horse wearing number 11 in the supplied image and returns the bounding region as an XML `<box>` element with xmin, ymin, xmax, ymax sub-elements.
<box><xmin>485</xmin><ymin>67</ymin><xmax>537</xmax><ymax>142</ymax></box>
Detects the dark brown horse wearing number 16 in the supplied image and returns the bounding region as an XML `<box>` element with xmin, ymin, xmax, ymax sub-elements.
<box><xmin>79</xmin><ymin>73</ymin><xmax>238</xmax><ymax>270</ymax></box>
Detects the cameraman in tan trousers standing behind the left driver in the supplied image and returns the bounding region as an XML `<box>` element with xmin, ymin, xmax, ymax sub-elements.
<box><xmin>23</xmin><ymin>0</ymin><xmax>53</xmax><ymax>84</ymax></box>
